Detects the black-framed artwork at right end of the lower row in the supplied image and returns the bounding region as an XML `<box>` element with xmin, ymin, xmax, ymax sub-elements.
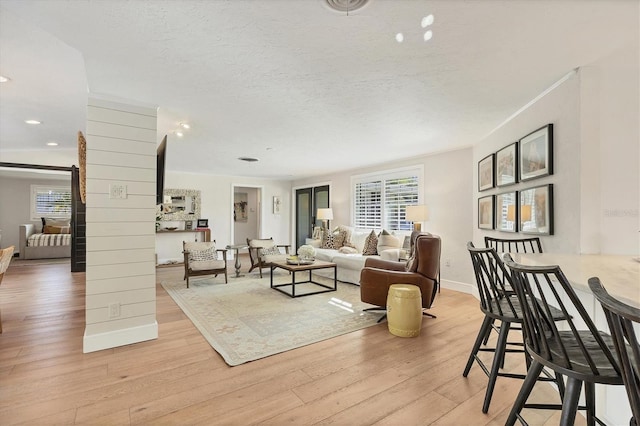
<box><xmin>518</xmin><ymin>184</ymin><xmax>553</xmax><ymax>235</ymax></box>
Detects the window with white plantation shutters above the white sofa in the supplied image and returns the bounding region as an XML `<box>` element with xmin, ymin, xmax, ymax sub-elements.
<box><xmin>352</xmin><ymin>167</ymin><xmax>422</xmax><ymax>231</ymax></box>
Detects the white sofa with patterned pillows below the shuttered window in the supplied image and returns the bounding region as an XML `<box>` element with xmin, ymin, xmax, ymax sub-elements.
<box><xmin>307</xmin><ymin>228</ymin><xmax>410</xmax><ymax>285</ymax></box>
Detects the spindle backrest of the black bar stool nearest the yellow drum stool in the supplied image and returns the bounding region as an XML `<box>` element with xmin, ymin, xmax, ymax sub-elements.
<box><xmin>467</xmin><ymin>241</ymin><xmax>522</xmax><ymax>318</ymax></box>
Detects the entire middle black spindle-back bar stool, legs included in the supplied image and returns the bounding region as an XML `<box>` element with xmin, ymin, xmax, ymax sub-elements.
<box><xmin>505</xmin><ymin>255</ymin><xmax>623</xmax><ymax>426</ymax></box>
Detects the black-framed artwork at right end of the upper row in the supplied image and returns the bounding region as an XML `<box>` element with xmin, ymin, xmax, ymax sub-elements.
<box><xmin>519</xmin><ymin>124</ymin><xmax>553</xmax><ymax>181</ymax></box>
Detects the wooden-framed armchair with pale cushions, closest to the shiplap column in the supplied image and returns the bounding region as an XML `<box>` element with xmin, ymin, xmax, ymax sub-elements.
<box><xmin>182</xmin><ymin>240</ymin><xmax>228</xmax><ymax>288</ymax></box>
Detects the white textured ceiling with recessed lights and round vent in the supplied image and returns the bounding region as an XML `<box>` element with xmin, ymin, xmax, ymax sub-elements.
<box><xmin>0</xmin><ymin>0</ymin><xmax>639</xmax><ymax>179</ymax></box>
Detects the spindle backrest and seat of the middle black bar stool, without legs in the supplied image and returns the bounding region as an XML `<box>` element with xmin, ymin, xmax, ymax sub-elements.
<box><xmin>505</xmin><ymin>255</ymin><xmax>621</xmax><ymax>384</ymax></box>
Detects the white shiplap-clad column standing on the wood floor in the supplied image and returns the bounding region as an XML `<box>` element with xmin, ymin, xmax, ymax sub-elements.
<box><xmin>83</xmin><ymin>97</ymin><xmax>158</xmax><ymax>353</ymax></box>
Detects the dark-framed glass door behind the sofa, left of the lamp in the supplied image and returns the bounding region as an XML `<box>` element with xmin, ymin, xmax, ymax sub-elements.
<box><xmin>296</xmin><ymin>185</ymin><xmax>329</xmax><ymax>252</ymax></box>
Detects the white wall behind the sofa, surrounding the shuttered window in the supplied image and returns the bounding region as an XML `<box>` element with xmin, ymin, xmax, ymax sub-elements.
<box><xmin>293</xmin><ymin>148</ymin><xmax>474</xmax><ymax>291</ymax></box>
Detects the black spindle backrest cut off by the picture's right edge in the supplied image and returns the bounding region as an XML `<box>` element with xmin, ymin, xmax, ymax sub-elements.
<box><xmin>589</xmin><ymin>277</ymin><xmax>640</xmax><ymax>425</ymax></box>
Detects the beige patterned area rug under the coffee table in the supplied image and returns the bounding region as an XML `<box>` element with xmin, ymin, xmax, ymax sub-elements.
<box><xmin>161</xmin><ymin>272</ymin><xmax>381</xmax><ymax>366</ymax></box>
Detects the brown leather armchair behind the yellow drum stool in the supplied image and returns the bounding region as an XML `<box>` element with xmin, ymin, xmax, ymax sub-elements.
<box><xmin>360</xmin><ymin>232</ymin><xmax>441</xmax><ymax>320</ymax></box>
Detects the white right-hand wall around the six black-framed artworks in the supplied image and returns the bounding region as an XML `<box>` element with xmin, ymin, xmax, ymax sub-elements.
<box><xmin>473</xmin><ymin>44</ymin><xmax>640</xmax><ymax>255</ymax></box>
